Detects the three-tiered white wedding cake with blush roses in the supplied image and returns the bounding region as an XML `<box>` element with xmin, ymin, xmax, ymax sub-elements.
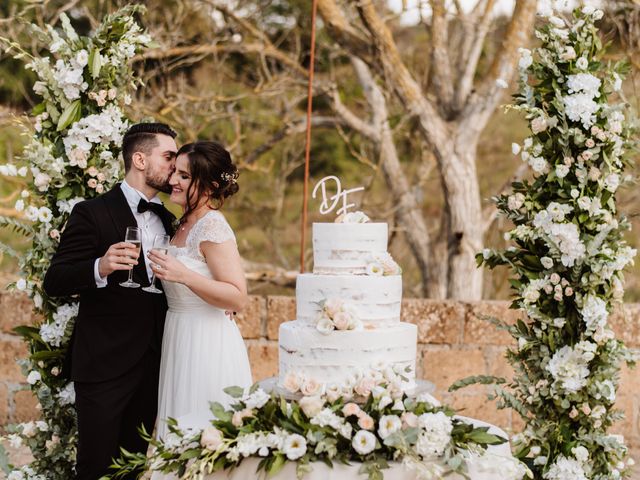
<box><xmin>279</xmin><ymin>212</ymin><xmax>417</xmax><ymax>397</ymax></box>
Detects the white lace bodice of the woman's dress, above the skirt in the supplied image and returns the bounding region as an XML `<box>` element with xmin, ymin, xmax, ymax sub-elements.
<box><xmin>162</xmin><ymin>210</ymin><xmax>235</xmax><ymax>312</ymax></box>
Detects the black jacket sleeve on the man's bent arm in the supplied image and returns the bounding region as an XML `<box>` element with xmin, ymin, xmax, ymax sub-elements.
<box><xmin>42</xmin><ymin>203</ymin><xmax>103</xmax><ymax>297</ymax></box>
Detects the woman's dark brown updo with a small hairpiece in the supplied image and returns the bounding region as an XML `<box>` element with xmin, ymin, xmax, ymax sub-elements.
<box><xmin>176</xmin><ymin>140</ymin><xmax>239</xmax><ymax>218</ymax></box>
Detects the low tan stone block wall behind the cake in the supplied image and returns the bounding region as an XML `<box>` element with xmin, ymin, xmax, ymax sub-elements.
<box><xmin>0</xmin><ymin>293</ymin><xmax>640</xmax><ymax>449</ymax></box>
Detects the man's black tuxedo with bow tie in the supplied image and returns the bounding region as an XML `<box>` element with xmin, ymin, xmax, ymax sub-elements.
<box><xmin>43</xmin><ymin>185</ymin><xmax>174</xmax><ymax>480</ymax></box>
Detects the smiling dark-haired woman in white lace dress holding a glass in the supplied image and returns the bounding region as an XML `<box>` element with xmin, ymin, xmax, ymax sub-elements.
<box><xmin>149</xmin><ymin>141</ymin><xmax>251</xmax><ymax>438</ymax></box>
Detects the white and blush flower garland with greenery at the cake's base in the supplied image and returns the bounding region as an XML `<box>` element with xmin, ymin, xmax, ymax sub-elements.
<box><xmin>111</xmin><ymin>386</ymin><xmax>527</xmax><ymax>480</ymax></box>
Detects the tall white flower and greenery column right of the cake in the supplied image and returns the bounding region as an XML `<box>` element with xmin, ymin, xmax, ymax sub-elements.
<box><xmin>452</xmin><ymin>6</ymin><xmax>636</xmax><ymax>480</ymax></box>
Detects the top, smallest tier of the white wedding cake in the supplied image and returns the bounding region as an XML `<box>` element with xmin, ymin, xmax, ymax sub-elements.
<box><xmin>313</xmin><ymin>223</ymin><xmax>388</xmax><ymax>275</ymax></box>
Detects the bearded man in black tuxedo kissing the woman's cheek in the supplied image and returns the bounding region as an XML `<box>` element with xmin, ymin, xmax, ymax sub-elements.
<box><xmin>43</xmin><ymin>123</ymin><xmax>177</xmax><ymax>480</ymax></box>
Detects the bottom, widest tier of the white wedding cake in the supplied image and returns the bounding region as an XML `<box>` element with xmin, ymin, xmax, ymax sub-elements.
<box><xmin>279</xmin><ymin>321</ymin><xmax>418</xmax><ymax>390</ymax></box>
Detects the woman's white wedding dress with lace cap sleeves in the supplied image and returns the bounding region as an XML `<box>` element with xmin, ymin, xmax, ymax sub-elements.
<box><xmin>154</xmin><ymin>210</ymin><xmax>252</xmax><ymax>442</ymax></box>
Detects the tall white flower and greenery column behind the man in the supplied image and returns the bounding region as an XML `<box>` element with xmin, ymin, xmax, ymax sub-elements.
<box><xmin>0</xmin><ymin>6</ymin><xmax>150</xmax><ymax>480</ymax></box>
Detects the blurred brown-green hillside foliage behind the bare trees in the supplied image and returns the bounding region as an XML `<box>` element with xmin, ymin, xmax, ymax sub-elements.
<box><xmin>0</xmin><ymin>0</ymin><xmax>640</xmax><ymax>301</ymax></box>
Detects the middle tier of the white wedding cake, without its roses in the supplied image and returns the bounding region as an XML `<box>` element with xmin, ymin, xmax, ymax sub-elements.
<box><xmin>296</xmin><ymin>273</ymin><xmax>402</xmax><ymax>327</ymax></box>
